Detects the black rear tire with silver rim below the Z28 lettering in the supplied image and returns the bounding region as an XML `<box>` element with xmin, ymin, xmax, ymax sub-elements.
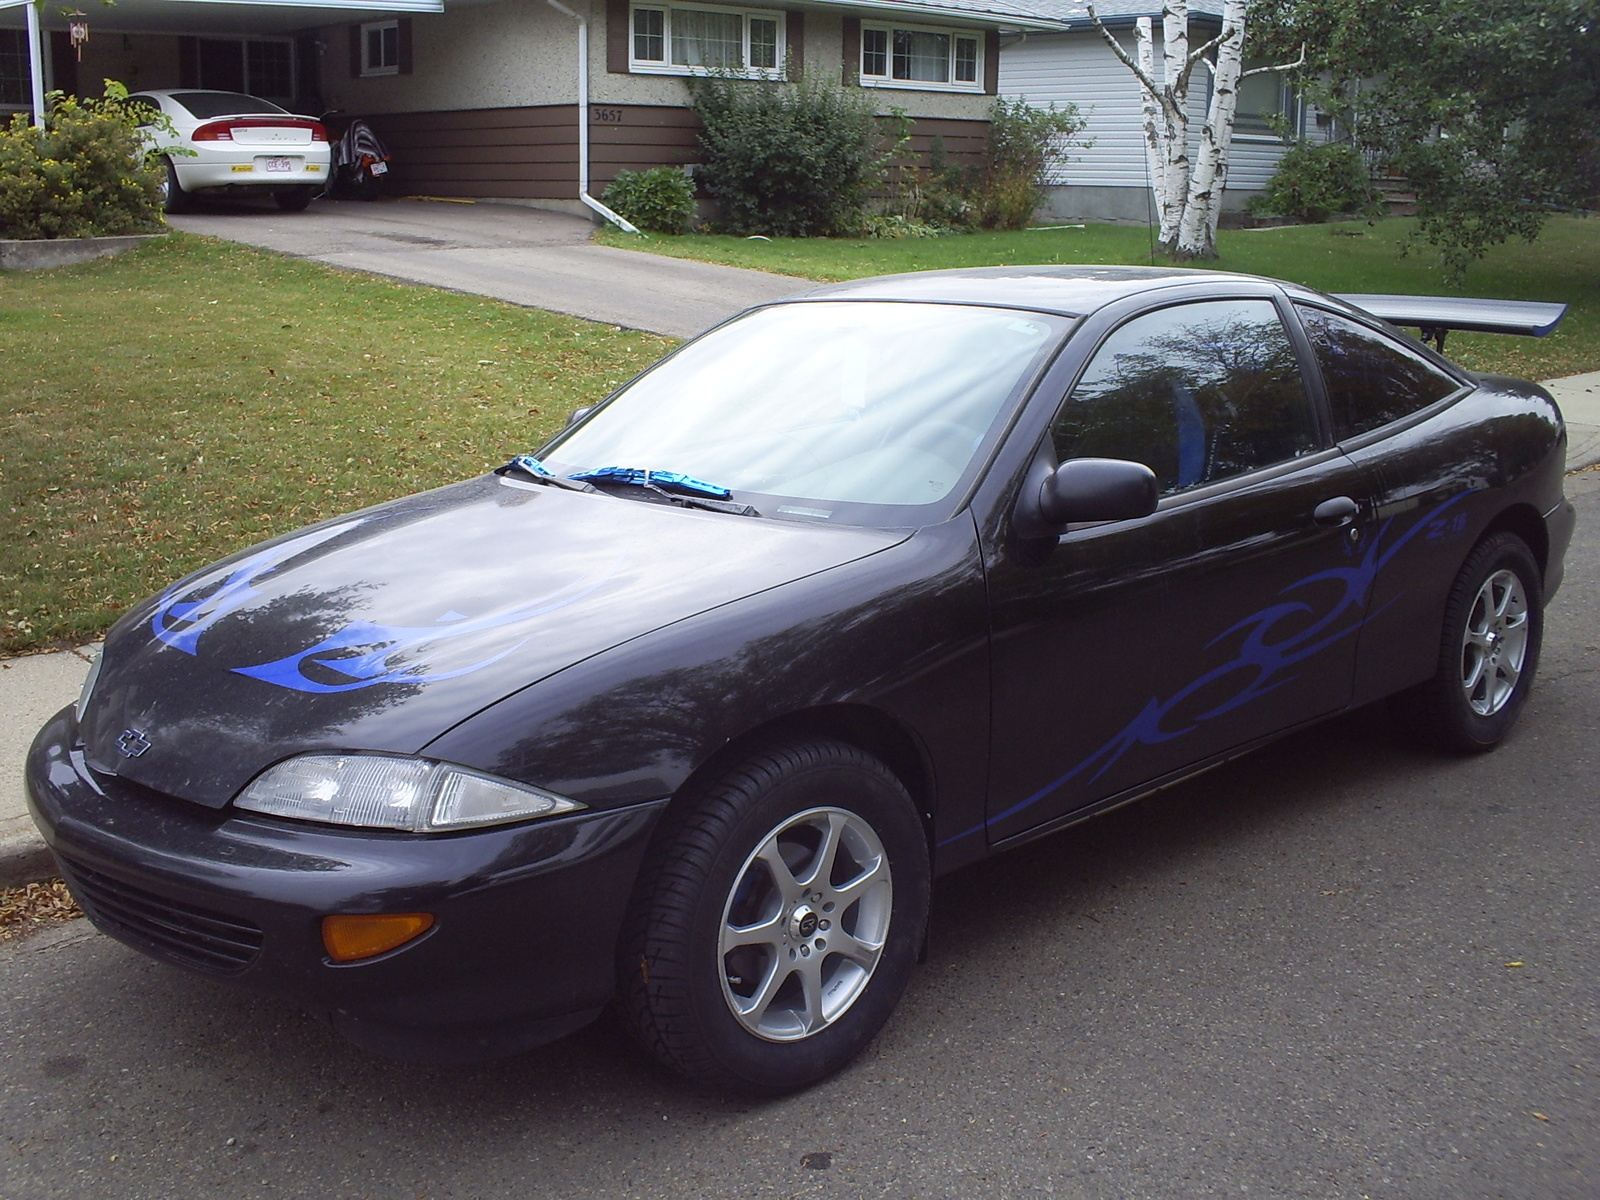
<box><xmin>1390</xmin><ymin>533</ymin><xmax>1544</xmax><ymax>754</ymax></box>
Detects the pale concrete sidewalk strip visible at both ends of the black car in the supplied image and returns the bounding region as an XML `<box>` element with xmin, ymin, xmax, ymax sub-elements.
<box><xmin>0</xmin><ymin>371</ymin><xmax>1600</xmax><ymax>888</ymax></box>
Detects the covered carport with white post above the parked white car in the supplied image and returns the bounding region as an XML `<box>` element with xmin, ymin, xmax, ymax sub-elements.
<box><xmin>0</xmin><ymin>0</ymin><xmax>445</xmax><ymax>125</ymax></box>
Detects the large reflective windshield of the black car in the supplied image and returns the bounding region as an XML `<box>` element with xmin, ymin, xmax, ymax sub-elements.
<box><xmin>541</xmin><ymin>301</ymin><xmax>1070</xmax><ymax>525</ymax></box>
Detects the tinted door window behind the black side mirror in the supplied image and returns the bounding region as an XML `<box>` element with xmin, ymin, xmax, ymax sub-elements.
<box><xmin>1053</xmin><ymin>301</ymin><xmax>1317</xmax><ymax>491</ymax></box>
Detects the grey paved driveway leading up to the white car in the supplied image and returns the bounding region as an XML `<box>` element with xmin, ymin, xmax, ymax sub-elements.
<box><xmin>171</xmin><ymin>200</ymin><xmax>816</xmax><ymax>338</ymax></box>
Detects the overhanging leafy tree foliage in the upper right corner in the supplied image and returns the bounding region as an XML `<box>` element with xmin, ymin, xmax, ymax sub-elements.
<box><xmin>1254</xmin><ymin>0</ymin><xmax>1600</xmax><ymax>275</ymax></box>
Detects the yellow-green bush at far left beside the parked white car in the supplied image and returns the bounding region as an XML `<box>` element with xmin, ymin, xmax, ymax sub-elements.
<box><xmin>0</xmin><ymin>80</ymin><xmax>165</xmax><ymax>238</ymax></box>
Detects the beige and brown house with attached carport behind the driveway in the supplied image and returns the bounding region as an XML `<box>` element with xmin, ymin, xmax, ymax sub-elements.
<box><xmin>9</xmin><ymin>0</ymin><xmax>1061</xmax><ymax>224</ymax></box>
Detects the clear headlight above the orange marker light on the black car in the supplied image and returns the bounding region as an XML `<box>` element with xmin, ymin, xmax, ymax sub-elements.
<box><xmin>234</xmin><ymin>754</ymin><xmax>584</xmax><ymax>834</ymax></box>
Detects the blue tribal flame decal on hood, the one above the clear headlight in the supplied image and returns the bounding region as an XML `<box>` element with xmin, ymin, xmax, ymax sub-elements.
<box><xmin>234</xmin><ymin>546</ymin><xmax>627</xmax><ymax>693</ymax></box>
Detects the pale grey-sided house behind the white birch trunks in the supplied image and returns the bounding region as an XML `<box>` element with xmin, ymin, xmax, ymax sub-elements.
<box><xmin>994</xmin><ymin>0</ymin><xmax>1331</xmax><ymax>224</ymax></box>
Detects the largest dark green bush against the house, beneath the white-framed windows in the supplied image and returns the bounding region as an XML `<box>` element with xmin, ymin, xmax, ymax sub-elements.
<box><xmin>690</xmin><ymin>77</ymin><xmax>885</xmax><ymax>237</ymax></box>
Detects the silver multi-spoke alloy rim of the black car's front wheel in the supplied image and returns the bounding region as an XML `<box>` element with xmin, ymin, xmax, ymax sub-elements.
<box><xmin>718</xmin><ymin>808</ymin><xmax>894</xmax><ymax>1042</ymax></box>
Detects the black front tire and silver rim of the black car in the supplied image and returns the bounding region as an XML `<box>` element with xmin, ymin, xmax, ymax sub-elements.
<box><xmin>619</xmin><ymin>739</ymin><xmax>931</xmax><ymax>1094</ymax></box>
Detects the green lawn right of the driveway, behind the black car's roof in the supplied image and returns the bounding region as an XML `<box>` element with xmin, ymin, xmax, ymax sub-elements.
<box><xmin>600</xmin><ymin>218</ymin><xmax>1600</xmax><ymax>379</ymax></box>
